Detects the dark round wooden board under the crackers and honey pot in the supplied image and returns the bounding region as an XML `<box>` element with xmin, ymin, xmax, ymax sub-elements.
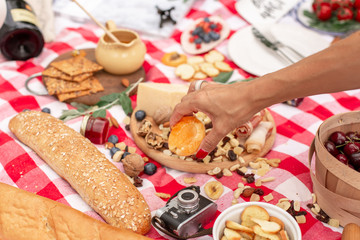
<box><xmin>48</xmin><ymin>48</ymin><xmax>146</xmax><ymax>105</ymax></box>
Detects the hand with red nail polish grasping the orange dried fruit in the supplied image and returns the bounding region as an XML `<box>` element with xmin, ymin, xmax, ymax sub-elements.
<box><xmin>170</xmin><ymin>81</ymin><xmax>259</xmax><ymax>159</ymax></box>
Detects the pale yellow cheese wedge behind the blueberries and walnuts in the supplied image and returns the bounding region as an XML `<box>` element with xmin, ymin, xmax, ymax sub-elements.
<box><xmin>136</xmin><ymin>82</ymin><xmax>189</xmax><ymax>117</ymax></box>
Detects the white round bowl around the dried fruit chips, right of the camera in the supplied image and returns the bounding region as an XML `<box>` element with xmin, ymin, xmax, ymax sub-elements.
<box><xmin>212</xmin><ymin>202</ymin><xmax>302</xmax><ymax>240</ymax></box>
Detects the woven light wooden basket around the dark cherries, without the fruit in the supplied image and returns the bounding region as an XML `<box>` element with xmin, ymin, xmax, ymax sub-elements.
<box><xmin>309</xmin><ymin>111</ymin><xmax>360</xmax><ymax>226</ymax></box>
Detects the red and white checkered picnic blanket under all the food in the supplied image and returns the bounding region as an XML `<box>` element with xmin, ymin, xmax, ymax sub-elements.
<box><xmin>0</xmin><ymin>0</ymin><xmax>360</xmax><ymax>240</ymax></box>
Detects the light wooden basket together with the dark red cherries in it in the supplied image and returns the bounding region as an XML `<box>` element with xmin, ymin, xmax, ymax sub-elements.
<box><xmin>309</xmin><ymin>111</ymin><xmax>360</xmax><ymax>226</ymax></box>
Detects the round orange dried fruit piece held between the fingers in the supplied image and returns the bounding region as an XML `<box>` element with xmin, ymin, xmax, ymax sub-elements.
<box><xmin>168</xmin><ymin>116</ymin><xmax>205</xmax><ymax>156</ymax></box>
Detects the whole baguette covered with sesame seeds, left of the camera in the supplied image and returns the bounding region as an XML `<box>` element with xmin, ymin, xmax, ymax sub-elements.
<box><xmin>9</xmin><ymin>111</ymin><xmax>151</xmax><ymax>234</ymax></box>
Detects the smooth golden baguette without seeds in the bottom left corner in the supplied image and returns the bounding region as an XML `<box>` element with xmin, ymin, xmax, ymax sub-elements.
<box><xmin>0</xmin><ymin>183</ymin><xmax>150</xmax><ymax>240</ymax></box>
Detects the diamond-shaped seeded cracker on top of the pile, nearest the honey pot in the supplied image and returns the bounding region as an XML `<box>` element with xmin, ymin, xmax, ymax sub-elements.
<box><xmin>50</xmin><ymin>56</ymin><xmax>103</xmax><ymax>76</ymax></box>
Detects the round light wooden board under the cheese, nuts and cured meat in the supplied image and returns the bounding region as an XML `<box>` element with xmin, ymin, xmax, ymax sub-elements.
<box><xmin>130</xmin><ymin>109</ymin><xmax>276</xmax><ymax>173</ymax></box>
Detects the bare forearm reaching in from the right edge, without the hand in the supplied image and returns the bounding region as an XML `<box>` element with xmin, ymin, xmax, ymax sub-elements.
<box><xmin>249</xmin><ymin>31</ymin><xmax>360</xmax><ymax>109</ymax></box>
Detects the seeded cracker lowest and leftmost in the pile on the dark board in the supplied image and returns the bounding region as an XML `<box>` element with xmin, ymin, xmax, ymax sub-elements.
<box><xmin>43</xmin><ymin>76</ymin><xmax>91</xmax><ymax>95</ymax></box>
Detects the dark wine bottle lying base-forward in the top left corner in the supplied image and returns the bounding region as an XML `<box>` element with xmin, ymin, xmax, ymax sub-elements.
<box><xmin>0</xmin><ymin>0</ymin><xmax>44</xmax><ymax>60</ymax></box>
